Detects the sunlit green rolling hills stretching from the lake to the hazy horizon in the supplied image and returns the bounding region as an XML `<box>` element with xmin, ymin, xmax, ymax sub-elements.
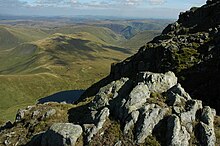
<box><xmin>0</xmin><ymin>20</ymin><xmax>169</xmax><ymax>121</ymax></box>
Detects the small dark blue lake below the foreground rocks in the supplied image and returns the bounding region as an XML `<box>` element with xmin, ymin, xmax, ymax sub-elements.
<box><xmin>38</xmin><ymin>90</ymin><xmax>84</xmax><ymax>104</ymax></box>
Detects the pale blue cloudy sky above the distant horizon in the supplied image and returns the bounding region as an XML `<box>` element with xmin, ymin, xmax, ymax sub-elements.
<box><xmin>0</xmin><ymin>0</ymin><xmax>206</xmax><ymax>19</ymax></box>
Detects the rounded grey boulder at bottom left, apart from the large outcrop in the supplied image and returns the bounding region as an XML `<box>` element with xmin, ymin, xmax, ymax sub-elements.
<box><xmin>41</xmin><ymin>123</ymin><xmax>83</xmax><ymax>146</ymax></box>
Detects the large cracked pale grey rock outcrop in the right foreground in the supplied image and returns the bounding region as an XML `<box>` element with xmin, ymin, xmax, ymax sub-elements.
<box><xmin>76</xmin><ymin>72</ymin><xmax>215</xmax><ymax>146</ymax></box>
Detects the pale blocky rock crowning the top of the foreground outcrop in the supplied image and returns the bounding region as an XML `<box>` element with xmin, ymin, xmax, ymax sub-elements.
<box><xmin>138</xmin><ymin>71</ymin><xmax>177</xmax><ymax>93</ymax></box>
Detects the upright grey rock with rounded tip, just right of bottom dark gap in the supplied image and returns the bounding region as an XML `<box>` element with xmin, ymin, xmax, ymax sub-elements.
<box><xmin>167</xmin><ymin>115</ymin><xmax>190</xmax><ymax>146</ymax></box>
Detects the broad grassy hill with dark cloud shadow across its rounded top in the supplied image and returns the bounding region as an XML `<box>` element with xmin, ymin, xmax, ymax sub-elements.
<box><xmin>0</xmin><ymin>33</ymin><xmax>130</xmax><ymax>120</ymax></box>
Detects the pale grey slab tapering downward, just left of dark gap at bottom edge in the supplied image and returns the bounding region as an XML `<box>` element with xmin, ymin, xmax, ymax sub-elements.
<box><xmin>136</xmin><ymin>105</ymin><xmax>169</xmax><ymax>143</ymax></box>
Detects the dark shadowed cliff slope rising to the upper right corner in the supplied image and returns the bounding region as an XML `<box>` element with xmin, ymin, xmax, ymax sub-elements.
<box><xmin>82</xmin><ymin>0</ymin><xmax>220</xmax><ymax>113</ymax></box>
